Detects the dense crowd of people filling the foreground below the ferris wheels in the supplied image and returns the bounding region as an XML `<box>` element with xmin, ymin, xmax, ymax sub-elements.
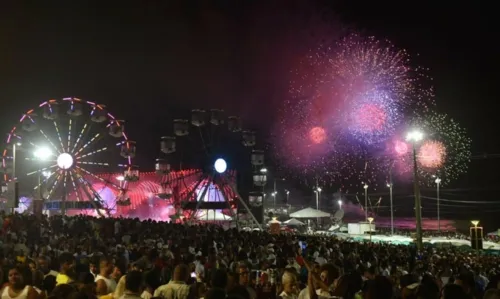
<box><xmin>0</xmin><ymin>213</ymin><xmax>500</xmax><ymax>299</ymax></box>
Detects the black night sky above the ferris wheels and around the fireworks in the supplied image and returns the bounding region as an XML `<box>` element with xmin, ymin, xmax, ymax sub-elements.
<box><xmin>0</xmin><ymin>0</ymin><xmax>500</xmax><ymax>225</ymax></box>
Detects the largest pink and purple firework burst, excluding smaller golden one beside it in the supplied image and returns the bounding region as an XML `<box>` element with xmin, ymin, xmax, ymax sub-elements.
<box><xmin>274</xmin><ymin>34</ymin><xmax>433</xmax><ymax>186</ymax></box>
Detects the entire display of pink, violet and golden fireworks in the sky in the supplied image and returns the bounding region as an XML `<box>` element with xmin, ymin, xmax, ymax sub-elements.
<box><xmin>275</xmin><ymin>30</ymin><xmax>470</xmax><ymax>190</ymax></box>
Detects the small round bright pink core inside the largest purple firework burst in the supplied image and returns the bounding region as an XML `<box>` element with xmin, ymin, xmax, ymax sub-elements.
<box><xmin>353</xmin><ymin>103</ymin><xmax>387</xmax><ymax>133</ymax></box>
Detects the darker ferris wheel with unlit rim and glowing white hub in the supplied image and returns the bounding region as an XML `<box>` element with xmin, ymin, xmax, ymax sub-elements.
<box><xmin>155</xmin><ymin>109</ymin><xmax>264</xmax><ymax>227</ymax></box>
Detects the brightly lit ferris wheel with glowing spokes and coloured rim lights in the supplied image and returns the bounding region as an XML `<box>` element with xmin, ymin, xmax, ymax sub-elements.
<box><xmin>1</xmin><ymin>97</ymin><xmax>138</xmax><ymax>215</ymax></box>
